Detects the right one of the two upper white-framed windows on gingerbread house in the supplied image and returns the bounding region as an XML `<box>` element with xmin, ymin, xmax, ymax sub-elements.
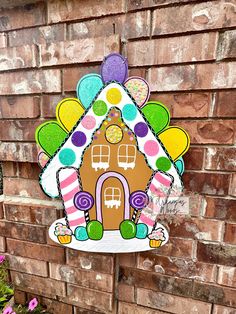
<box><xmin>118</xmin><ymin>144</ymin><xmax>136</xmax><ymax>170</ymax></box>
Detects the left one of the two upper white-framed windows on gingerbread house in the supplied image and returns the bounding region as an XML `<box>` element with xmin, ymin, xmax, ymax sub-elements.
<box><xmin>91</xmin><ymin>145</ymin><xmax>110</xmax><ymax>171</ymax></box>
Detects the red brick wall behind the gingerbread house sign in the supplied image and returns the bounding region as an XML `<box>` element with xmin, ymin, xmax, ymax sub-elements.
<box><xmin>0</xmin><ymin>0</ymin><xmax>236</xmax><ymax>314</ymax></box>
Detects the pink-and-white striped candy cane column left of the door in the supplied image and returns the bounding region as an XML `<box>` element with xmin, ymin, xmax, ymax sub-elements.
<box><xmin>58</xmin><ymin>167</ymin><xmax>88</xmax><ymax>227</ymax></box>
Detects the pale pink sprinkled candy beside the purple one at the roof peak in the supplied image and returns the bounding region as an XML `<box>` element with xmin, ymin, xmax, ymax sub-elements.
<box><xmin>124</xmin><ymin>76</ymin><xmax>150</xmax><ymax>107</ymax></box>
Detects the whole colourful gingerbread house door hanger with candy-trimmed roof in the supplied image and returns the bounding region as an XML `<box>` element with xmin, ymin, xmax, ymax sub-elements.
<box><xmin>36</xmin><ymin>53</ymin><xmax>190</xmax><ymax>253</ymax></box>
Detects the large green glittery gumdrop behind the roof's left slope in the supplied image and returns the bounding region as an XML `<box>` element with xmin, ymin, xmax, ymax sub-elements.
<box><xmin>35</xmin><ymin>121</ymin><xmax>67</xmax><ymax>156</ymax></box>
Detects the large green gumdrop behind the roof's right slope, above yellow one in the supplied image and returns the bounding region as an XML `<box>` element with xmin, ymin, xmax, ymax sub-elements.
<box><xmin>141</xmin><ymin>101</ymin><xmax>170</xmax><ymax>134</ymax></box>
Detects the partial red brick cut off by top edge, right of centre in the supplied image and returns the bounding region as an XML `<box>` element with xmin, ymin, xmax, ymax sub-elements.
<box><xmin>128</xmin><ymin>0</ymin><xmax>195</xmax><ymax>11</ymax></box>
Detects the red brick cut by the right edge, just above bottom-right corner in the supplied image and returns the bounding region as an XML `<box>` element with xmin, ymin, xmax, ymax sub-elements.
<box><xmin>193</xmin><ymin>282</ymin><xmax>236</xmax><ymax>307</ymax></box>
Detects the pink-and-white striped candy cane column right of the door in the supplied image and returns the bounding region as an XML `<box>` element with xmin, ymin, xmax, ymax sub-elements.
<box><xmin>138</xmin><ymin>172</ymin><xmax>173</xmax><ymax>233</ymax></box>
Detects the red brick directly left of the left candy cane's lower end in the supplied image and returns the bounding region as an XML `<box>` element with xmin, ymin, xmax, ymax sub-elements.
<box><xmin>4</xmin><ymin>202</ymin><xmax>58</xmax><ymax>226</ymax></box>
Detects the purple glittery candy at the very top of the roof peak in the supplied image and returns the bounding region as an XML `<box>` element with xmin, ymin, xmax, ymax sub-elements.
<box><xmin>101</xmin><ymin>53</ymin><xmax>128</xmax><ymax>84</ymax></box>
